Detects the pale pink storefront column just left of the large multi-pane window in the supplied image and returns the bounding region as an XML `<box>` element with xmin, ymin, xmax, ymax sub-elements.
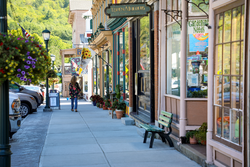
<box><xmin>207</xmin><ymin>0</ymin><xmax>215</xmax><ymax>164</ymax></box>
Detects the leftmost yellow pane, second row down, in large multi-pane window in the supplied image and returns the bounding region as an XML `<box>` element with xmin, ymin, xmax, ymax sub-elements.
<box><xmin>214</xmin><ymin>45</ymin><xmax>222</xmax><ymax>75</ymax></box>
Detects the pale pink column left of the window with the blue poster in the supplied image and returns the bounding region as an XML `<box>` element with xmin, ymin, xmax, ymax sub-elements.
<box><xmin>179</xmin><ymin>1</ymin><xmax>187</xmax><ymax>139</ymax></box>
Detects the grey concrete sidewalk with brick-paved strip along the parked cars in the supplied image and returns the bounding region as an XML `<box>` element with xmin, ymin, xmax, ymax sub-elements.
<box><xmin>10</xmin><ymin>98</ymin><xmax>199</xmax><ymax>167</ymax></box>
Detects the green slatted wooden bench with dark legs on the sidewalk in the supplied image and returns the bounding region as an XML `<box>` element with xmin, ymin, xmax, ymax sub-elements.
<box><xmin>140</xmin><ymin>111</ymin><xmax>174</xmax><ymax>148</ymax></box>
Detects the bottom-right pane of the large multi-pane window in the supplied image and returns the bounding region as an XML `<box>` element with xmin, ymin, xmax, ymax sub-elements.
<box><xmin>230</xmin><ymin>110</ymin><xmax>240</xmax><ymax>143</ymax></box>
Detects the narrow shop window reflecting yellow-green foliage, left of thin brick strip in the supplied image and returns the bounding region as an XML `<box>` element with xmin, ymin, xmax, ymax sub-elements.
<box><xmin>125</xmin><ymin>27</ymin><xmax>129</xmax><ymax>100</ymax></box>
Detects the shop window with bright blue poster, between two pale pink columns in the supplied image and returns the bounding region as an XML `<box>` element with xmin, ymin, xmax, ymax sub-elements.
<box><xmin>186</xmin><ymin>20</ymin><xmax>209</xmax><ymax>98</ymax></box>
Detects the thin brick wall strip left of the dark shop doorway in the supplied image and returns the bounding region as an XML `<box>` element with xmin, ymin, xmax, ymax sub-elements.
<box><xmin>128</xmin><ymin>27</ymin><xmax>134</xmax><ymax>107</ymax></box>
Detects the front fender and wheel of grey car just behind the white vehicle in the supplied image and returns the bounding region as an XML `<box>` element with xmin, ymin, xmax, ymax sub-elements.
<box><xmin>16</xmin><ymin>93</ymin><xmax>37</xmax><ymax>118</ymax></box>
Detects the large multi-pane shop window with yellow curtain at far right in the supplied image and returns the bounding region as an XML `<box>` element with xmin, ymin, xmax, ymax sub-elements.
<box><xmin>214</xmin><ymin>5</ymin><xmax>244</xmax><ymax>145</ymax></box>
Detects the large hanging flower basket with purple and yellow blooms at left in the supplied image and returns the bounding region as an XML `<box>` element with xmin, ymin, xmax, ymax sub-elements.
<box><xmin>0</xmin><ymin>33</ymin><xmax>51</xmax><ymax>85</ymax></box>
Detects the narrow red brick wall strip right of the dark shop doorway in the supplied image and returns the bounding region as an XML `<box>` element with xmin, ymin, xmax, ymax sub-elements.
<box><xmin>154</xmin><ymin>10</ymin><xmax>159</xmax><ymax>120</ymax></box>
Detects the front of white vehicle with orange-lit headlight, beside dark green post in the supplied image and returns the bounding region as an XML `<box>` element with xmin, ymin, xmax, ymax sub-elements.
<box><xmin>9</xmin><ymin>92</ymin><xmax>22</xmax><ymax>138</ymax></box>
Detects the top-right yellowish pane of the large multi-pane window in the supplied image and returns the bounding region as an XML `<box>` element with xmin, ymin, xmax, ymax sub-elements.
<box><xmin>232</xmin><ymin>6</ymin><xmax>241</xmax><ymax>41</ymax></box>
